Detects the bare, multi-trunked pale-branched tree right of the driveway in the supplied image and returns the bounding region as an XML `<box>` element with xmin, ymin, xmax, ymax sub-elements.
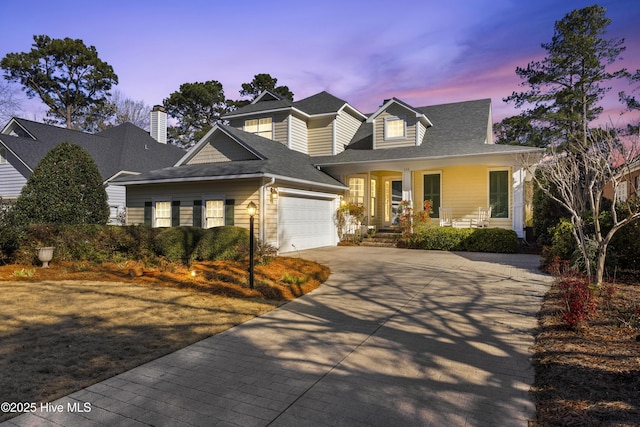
<box><xmin>522</xmin><ymin>130</ymin><xmax>640</xmax><ymax>285</ymax></box>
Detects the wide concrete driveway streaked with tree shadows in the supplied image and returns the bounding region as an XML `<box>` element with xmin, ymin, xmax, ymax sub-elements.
<box><xmin>6</xmin><ymin>247</ymin><xmax>550</xmax><ymax>426</ymax></box>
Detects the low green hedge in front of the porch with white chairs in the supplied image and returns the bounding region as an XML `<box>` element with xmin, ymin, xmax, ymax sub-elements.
<box><xmin>407</xmin><ymin>227</ymin><xmax>518</xmax><ymax>253</ymax></box>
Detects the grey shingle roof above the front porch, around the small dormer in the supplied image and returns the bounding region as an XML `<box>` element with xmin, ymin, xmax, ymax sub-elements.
<box><xmin>314</xmin><ymin>99</ymin><xmax>535</xmax><ymax>165</ymax></box>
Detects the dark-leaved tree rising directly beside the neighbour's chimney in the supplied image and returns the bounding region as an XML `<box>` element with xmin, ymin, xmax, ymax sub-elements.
<box><xmin>162</xmin><ymin>80</ymin><xmax>228</xmax><ymax>147</ymax></box>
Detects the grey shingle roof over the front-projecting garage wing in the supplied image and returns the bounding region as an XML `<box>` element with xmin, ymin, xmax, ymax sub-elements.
<box><xmin>114</xmin><ymin>125</ymin><xmax>344</xmax><ymax>188</ymax></box>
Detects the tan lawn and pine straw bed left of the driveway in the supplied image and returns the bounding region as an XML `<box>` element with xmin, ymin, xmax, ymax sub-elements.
<box><xmin>0</xmin><ymin>257</ymin><xmax>329</xmax><ymax>421</ymax></box>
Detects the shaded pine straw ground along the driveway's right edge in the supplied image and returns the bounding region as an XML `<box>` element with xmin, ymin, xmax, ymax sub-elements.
<box><xmin>532</xmin><ymin>281</ymin><xmax>640</xmax><ymax>426</ymax></box>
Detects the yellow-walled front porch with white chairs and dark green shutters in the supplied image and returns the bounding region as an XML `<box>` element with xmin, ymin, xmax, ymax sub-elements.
<box><xmin>344</xmin><ymin>165</ymin><xmax>525</xmax><ymax>237</ymax></box>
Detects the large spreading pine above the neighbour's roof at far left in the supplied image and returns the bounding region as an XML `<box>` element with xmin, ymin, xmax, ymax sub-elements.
<box><xmin>0</xmin><ymin>35</ymin><xmax>118</xmax><ymax>128</ymax></box>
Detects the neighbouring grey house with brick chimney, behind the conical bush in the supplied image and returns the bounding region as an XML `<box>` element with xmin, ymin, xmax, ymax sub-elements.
<box><xmin>0</xmin><ymin>110</ymin><xmax>185</xmax><ymax>223</ymax></box>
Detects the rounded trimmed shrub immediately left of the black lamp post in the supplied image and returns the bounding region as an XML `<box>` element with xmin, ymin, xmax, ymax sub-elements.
<box><xmin>191</xmin><ymin>226</ymin><xmax>249</xmax><ymax>261</ymax></box>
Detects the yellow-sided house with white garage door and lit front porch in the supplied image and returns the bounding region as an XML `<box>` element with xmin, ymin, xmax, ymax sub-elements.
<box><xmin>115</xmin><ymin>91</ymin><xmax>541</xmax><ymax>252</ymax></box>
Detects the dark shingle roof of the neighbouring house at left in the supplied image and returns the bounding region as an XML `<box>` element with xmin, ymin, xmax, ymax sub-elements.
<box><xmin>0</xmin><ymin>118</ymin><xmax>184</xmax><ymax>180</ymax></box>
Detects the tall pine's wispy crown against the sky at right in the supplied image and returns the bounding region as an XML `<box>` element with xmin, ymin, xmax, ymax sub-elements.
<box><xmin>504</xmin><ymin>5</ymin><xmax>631</xmax><ymax>147</ymax></box>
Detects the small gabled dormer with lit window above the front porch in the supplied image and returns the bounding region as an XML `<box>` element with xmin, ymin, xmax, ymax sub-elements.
<box><xmin>367</xmin><ymin>98</ymin><xmax>433</xmax><ymax>149</ymax></box>
